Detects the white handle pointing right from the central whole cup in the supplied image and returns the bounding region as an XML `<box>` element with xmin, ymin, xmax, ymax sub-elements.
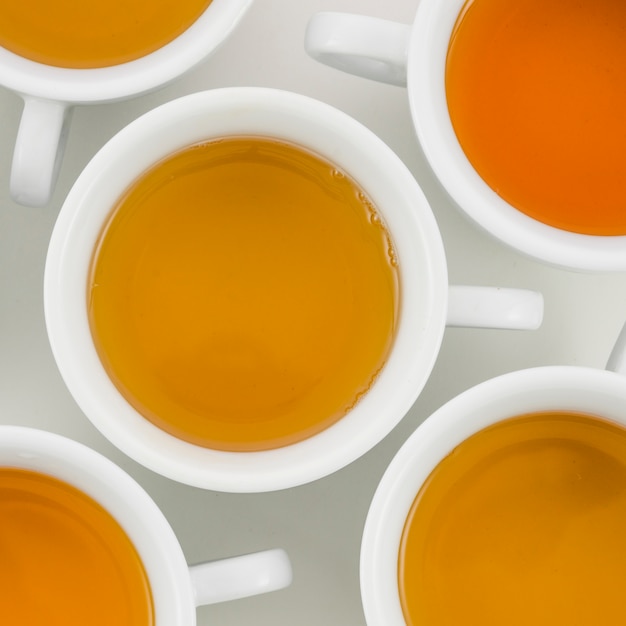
<box><xmin>446</xmin><ymin>285</ymin><xmax>543</xmax><ymax>330</ymax></box>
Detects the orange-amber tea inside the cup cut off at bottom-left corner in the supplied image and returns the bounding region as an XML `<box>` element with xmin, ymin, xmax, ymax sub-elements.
<box><xmin>0</xmin><ymin>468</ymin><xmax>154</xmax><ymax>626</ymax></box>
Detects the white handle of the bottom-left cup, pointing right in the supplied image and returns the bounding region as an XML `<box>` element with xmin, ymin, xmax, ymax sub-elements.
<box><xmin>189</xmin><ymin>549</ymin><xmax>293</xmax><ymax>606</ymax></box>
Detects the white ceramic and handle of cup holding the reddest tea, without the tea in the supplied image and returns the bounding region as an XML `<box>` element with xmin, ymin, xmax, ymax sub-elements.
<box><xmin>305</xmin><ymin>7</ymin><xmax>626</xmax><ymax>271</ymax></box>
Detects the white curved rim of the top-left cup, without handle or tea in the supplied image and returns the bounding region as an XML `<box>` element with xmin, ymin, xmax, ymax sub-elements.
<box><xmin>0</xmin><ymin>0</ymin><xmax>254</xmax><ymax>104</ymax></box>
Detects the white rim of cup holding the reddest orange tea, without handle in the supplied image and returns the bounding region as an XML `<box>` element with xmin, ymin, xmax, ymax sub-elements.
<box><xmin>407</xmin><ymin>0</ymin><xmax>626</xmax><ymax>272</ymax></box>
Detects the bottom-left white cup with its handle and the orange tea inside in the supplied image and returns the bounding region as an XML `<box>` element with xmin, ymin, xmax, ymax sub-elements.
<box><xmin>0</xmin><ymin>426</ymin><xmax>292</xmax><ymax>626</ymax></box>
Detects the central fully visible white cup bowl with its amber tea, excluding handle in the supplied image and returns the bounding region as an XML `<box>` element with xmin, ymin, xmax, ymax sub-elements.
<box><xmin>45</xmin><ymin>88</ymin><xmax>448</xmax><ymax>492</ymax></box>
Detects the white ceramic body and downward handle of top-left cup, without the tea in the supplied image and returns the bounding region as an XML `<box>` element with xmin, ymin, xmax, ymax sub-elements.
<box><xmin>0</xmin><ymin>0</ymin><xmax>253</xmax><ymax>206</ymax></box>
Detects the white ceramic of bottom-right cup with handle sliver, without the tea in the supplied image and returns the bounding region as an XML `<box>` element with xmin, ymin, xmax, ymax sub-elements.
<box><xmin>360</xmin><ymin>326</ymin><xmax>626</xmax><ymax>626</ymax></box>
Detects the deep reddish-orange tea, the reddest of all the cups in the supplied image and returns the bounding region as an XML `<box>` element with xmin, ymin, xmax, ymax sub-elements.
<box><xmin>446</xmin><ymin>0</ymin><xmax>626</xmax><ymax>235</ymax></box>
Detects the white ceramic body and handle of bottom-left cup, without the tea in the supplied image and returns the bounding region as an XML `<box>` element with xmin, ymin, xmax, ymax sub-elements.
<box><xmin>0</xmin><ymin>426</ymin><xmax>292</xmax><ymax>626</ymax></box>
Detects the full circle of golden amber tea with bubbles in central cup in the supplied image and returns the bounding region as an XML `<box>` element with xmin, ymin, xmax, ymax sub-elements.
<box><xmin>89</xmin><ymin>138</ymin><xmax>398</xmax><ymax>451</ymax></box>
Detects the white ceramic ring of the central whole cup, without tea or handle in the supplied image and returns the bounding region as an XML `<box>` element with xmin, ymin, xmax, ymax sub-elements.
<box><xmin>46</xmin><ymin>89</ymin><xmax>447</xmax><ymax>490</ymax></box>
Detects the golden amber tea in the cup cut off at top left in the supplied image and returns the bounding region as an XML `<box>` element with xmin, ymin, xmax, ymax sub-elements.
<box><xmin>0</xmin><ymin>0</ymin><xmax>211</xmax><ymax>68</ymax></box>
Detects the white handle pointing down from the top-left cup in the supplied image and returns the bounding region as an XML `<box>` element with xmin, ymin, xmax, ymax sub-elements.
<box><xmin>10</xmin><ymin>96</ymin><xmax>71</xmax><ymax>207</ymax></box>
